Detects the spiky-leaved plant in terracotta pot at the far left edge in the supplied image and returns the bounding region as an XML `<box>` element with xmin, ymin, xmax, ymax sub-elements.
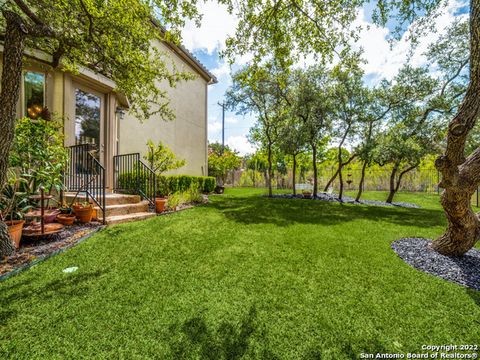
<box><xmin>0</xmin><ymin>169</ymin><xmax>31</xmax><ymax>249</ymax></box>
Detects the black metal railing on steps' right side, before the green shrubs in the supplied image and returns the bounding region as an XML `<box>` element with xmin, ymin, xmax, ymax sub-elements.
<box><xmin>113</xmin><ymin>153</ymin><xmax>157</xmax><ymax>209</ymax></box>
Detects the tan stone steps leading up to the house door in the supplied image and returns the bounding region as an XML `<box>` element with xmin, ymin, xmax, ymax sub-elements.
<box><xmin>65</xmin><ymin>193</ymin><xmax>155</xmax><ymax>225</ymax></box>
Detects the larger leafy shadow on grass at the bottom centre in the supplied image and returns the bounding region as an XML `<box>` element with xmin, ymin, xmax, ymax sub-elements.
<box><xmin>169</xmin><ymin>306</ymin><xmax>278</xmax><ymax>360</ymax></box>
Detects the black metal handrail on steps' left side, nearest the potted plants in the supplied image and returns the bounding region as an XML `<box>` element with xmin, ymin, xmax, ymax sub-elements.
<box><xmin>64</xmin><ymin>144</ymin><xmax>106</xmax><ymax>224</ymax></box>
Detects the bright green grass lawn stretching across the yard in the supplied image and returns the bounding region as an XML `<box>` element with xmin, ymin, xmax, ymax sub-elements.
<box><xmin>0</xmin><ymin>189</ymin><xmax>480</xmax><ymax>359</ymax></box>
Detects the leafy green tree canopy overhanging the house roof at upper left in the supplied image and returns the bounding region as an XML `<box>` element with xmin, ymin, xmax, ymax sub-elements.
<box><xmin>0</xmin><ymin>0</ymin><xmax>200</xmax><ymax>119</ymax></box>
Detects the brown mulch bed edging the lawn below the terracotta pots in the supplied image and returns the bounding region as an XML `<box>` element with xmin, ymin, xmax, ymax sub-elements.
<box><xmin>0</xmin><ymin>222</ymin><xmax>103</xmax><ymax>280</ymax></box>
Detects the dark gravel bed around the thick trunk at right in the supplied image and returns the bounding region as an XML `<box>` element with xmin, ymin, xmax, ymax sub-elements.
<box><xmin>391</xmin><ymin>238</ymin><xmax>480</xmax><ymax>291</ymax></box>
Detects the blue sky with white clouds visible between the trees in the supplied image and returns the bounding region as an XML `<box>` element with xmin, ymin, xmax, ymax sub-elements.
<box><xmin>182</xmin><ymin>0</ymin><xmax>466</xmax><ymax>155</ymax></box>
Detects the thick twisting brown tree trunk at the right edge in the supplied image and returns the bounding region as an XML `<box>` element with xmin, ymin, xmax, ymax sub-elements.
<box><xmin>432</xmin><ymin>0</ymin><xmax>480</xmax><ymax>256</ymax></box>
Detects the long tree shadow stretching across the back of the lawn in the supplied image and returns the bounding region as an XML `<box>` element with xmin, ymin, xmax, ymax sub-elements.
<box><xmin>210</xmin><ymin>196</ymin><xmax>445</xmax><ymax>227</ymax></box>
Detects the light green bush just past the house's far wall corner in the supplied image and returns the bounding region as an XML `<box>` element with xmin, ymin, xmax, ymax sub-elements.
<box><xmin>208</xmin><ymin>143</ymin><xmax>242</xmax><ymax>185</ymax></box>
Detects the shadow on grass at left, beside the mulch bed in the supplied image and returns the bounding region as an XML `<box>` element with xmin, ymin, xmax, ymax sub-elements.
<box><xmin>0</xmin><ymin>270</ymin><xmax>104</xmax><ymax>325</ymax></box>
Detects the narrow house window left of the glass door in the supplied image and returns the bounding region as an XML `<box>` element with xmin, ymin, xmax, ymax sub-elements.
<box><xmin>23</xmin><ymin>71</ymin><xmax>45</xmax><ymax>119</ymax></box>
